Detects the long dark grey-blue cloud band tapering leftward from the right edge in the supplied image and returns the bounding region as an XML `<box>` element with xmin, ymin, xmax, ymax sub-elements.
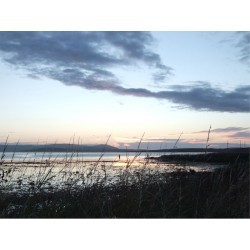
<box><xmin>109</xmin><ymin>83</ymin><xmax>250</xmax><ymax>112</ymax></box>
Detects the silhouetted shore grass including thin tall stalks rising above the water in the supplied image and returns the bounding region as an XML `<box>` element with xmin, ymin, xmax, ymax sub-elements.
<box><xmin>0</xmin><ymin>135</ymin><xmax>249</xmax><ymax>218</ymax></box>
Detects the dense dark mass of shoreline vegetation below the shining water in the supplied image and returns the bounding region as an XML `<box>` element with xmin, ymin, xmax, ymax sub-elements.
<box><xmin>0</xmin><ymin>150</ymin><xmax>249</xmax><ymax>218</ymax></box>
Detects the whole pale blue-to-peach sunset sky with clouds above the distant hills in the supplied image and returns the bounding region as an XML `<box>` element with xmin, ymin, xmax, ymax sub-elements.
<box><xmin>0</xmin><ymin>31</ymin><xmax>250</xmax><ymax>149</ymax></box>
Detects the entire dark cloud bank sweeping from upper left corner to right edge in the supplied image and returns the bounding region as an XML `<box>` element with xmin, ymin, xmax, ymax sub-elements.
<box><xmin>0</xmin><ymin>32</ymin><xmax>250</xmax><ymax>112</ymax></box>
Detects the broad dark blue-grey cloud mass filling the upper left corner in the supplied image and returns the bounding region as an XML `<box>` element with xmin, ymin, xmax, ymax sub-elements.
<box><xmin>0</xmin><ymin>32</ymin><xmax>172</xmax><ymax>83</ymax></box>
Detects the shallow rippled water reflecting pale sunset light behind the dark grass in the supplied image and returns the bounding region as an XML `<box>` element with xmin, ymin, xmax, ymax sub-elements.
<box><xmin>0</xmin><ymin>150</ymin><xmax>223</xmax><ymax>192</ymax></box>
